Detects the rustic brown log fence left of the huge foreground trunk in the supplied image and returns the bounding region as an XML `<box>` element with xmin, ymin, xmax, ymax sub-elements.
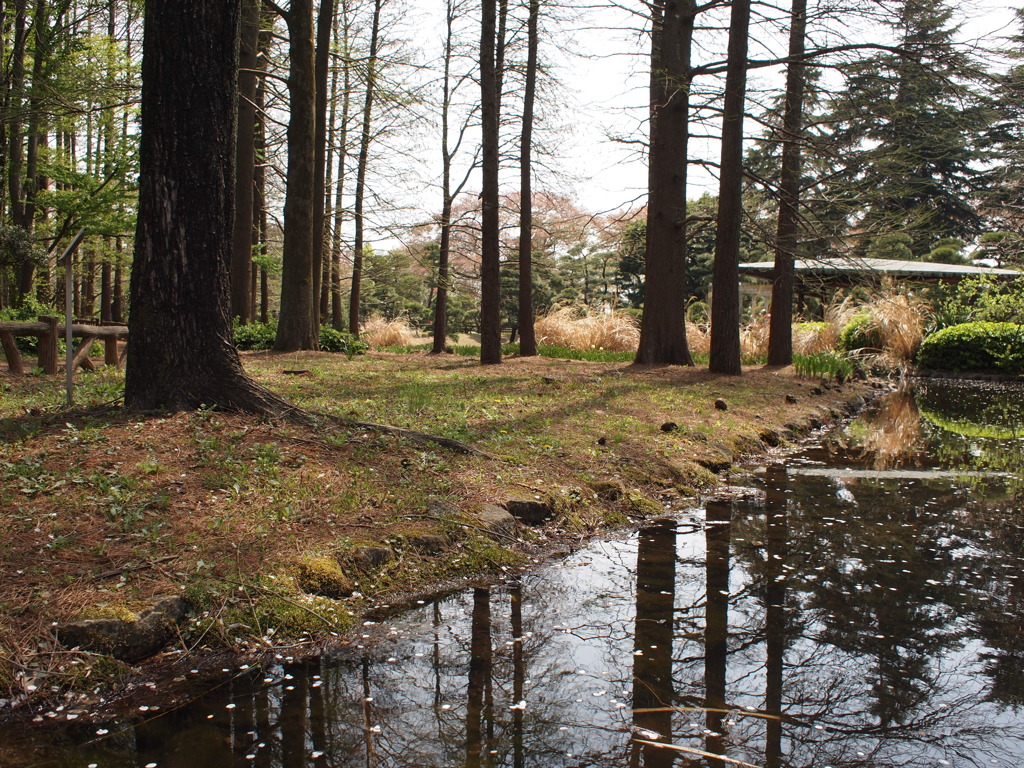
<box><xmin>0</xmin><ymin>315</ymin><xmax>128</xmax><ymax>376</ymax></box>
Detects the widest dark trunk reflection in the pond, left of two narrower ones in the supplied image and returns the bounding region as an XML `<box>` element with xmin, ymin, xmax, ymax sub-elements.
<box><xmin>630</xmin><ymin>520</ymin><xmax>676</xmax><ymax>768</ymax></box>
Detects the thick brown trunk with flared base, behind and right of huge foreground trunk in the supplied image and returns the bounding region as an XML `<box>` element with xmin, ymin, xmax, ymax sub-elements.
<box><xmin>273</xmin><ymin>0</ymin><xmax>324</xmax><ymax>352</ymax></box>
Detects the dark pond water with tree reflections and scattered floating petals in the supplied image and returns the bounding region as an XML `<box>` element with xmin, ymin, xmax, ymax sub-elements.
<box><xmin>8</xmin><ymin>384</ymin><xmax>1024</xmax><ymax>768</ymax></box>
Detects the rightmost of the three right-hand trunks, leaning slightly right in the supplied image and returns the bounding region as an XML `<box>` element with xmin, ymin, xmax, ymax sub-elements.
<box><xmin>768</xmin><ymin>0</ymin><xmax>807</xmax><ymax>366</ymax></box>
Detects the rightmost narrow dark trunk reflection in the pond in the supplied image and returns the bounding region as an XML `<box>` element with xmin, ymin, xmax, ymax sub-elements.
<box><xmin>765</xmin><ymin>464</ymin><xmax>790</xmax><ymax>768</ymax></box>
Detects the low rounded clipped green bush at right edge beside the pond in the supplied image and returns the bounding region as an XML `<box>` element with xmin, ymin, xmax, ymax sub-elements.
<box><xmin>918</xmin><ymin>323</ymin><xmax>1024</xmax><ymax>375</ymax></box>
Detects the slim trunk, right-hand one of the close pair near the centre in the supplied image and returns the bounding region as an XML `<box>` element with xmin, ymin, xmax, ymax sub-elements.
<box><xmin>519</xmin><ymin>0</ymin><xmax>541</xmax><ymax>357</ymax></box>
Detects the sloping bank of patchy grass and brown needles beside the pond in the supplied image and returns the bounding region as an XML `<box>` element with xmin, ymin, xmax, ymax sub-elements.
<box><xmin>0</xmin><ymin>352</ymin><xmax>870</xmax><ymax>720</ymax></box>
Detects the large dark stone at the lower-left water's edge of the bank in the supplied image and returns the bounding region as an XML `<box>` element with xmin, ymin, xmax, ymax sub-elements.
<box><xmin>57</xmin><ymin>597</ymin><xmax>188</xmax><ymax>663</ymax></box>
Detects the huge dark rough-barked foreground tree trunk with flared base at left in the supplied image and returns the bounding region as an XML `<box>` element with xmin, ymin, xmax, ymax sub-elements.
<box><xmin>125</xmin><ymin>0</ymin><xmax>289</xmax><ymax>414</ymax></box>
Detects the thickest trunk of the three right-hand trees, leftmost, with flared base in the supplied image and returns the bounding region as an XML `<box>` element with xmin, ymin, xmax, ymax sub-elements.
<box><xmin>636</xmin><ymin>0</ymin><xmax>696</xmax><ymax>366</ymax></box>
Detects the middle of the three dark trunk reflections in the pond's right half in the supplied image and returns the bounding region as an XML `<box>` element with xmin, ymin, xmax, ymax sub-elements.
<box><xmin>703</xmin><ymin>502</ymin><xmax>732</xmax><ymax>768</ymax></box>
